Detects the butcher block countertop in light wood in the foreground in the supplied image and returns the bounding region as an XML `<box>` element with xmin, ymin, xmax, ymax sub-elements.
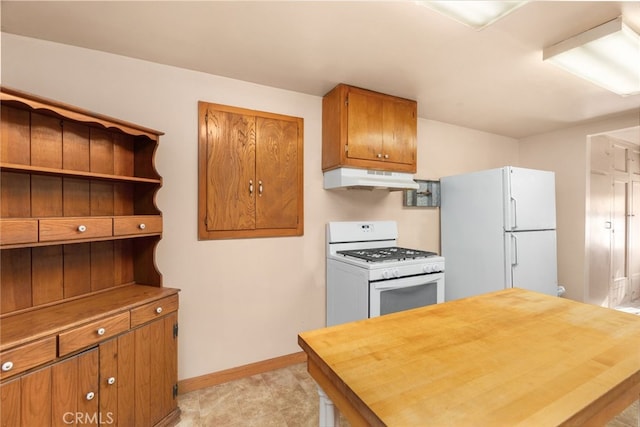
<box><xmin>298</xmin><ymin>288</ymin><xmax>640</xmax><ymax>427</ymax></box>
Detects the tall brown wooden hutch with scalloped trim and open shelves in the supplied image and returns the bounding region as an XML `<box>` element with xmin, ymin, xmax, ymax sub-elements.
<box><xmin>0</xmin><ymin>88</ymin><xmax>180</xmax><ymax>426</ymax></box>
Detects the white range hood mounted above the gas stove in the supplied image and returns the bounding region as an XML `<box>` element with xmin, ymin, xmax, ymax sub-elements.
<box><xmin>324</xmin><ymin>167</ymin><xmax>419</xmax><ymax>191</ymax></box>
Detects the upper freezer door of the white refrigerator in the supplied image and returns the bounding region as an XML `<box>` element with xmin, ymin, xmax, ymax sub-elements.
<box><xmin>503</xmin><ymin>167</ymin><xmax>556</xmax><ymax>231</ymax></box>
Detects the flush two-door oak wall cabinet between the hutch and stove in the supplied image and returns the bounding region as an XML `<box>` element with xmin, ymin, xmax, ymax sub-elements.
<box><xmin>198</xmin><ymin>102</ymin><xmax>304</xmax><ymax>239</ymax></box>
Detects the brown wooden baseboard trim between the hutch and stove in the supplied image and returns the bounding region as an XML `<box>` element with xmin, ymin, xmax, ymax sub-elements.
<box><xmin>178</xmin><ymin>351</ymin><xmax>307</xmax><ymax>394</ymax></box>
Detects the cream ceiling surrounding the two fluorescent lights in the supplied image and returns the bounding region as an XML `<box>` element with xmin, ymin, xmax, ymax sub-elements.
<box><xmin>1</xmin><ymin>0</ymin><xmax>640</xmax><ymax>143</ymax></box>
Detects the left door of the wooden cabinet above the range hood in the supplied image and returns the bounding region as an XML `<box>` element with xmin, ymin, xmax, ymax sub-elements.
<box><xmin>347</xmin><ymin>90</ymin><xmax>382</xmax><ymax>160</ymax></box>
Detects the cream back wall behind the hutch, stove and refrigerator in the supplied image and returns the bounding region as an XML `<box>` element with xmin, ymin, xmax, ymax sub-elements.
<box><xmin>1</xmin><ymin>34</ymin><xmax>518</xmax><ymax>379</ymax></box>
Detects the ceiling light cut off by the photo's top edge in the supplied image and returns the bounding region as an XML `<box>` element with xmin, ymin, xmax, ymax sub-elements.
<box><xmin>417</xmin><ymin>1</ymin><xmax>527</xmax><ymax>29</ymax></box>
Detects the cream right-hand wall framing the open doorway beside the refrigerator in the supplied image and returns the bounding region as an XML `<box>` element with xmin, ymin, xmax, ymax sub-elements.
<box><xmin>519</xmin><ymin>111</ymin><xmax>640</xmax><ymax>303</ymax></box>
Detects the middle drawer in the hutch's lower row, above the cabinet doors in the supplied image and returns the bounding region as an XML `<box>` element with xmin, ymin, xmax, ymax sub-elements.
<box><xmin>58</xmin><ymin>311</ymin><xmax>129</xmax><ymax>356</ymax></box>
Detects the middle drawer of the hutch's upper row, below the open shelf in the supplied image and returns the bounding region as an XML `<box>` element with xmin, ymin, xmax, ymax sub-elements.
<box><xmin>40</xmin><ymin>217</ymin><xmax>113</xmax><ymax>242</ymax></box>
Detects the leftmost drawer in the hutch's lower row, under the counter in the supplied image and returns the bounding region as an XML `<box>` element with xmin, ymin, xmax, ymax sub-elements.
<box><xmin>0</xmin><ymin>337</ymin><xmax>56</xmax><ymax>380</ymax></box>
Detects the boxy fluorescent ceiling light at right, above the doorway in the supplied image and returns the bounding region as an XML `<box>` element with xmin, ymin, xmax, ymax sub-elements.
<box><xmin>542</xmin><ymin>17</ymin><xmax>640</xmax><ymax>96</ymax></box>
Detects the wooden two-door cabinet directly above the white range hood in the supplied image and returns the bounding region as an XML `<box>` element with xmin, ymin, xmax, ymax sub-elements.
<box><xmin>322</xmin><ymin>84</ymin><xmax>418</xmax><ymax>173</ymax></box>
